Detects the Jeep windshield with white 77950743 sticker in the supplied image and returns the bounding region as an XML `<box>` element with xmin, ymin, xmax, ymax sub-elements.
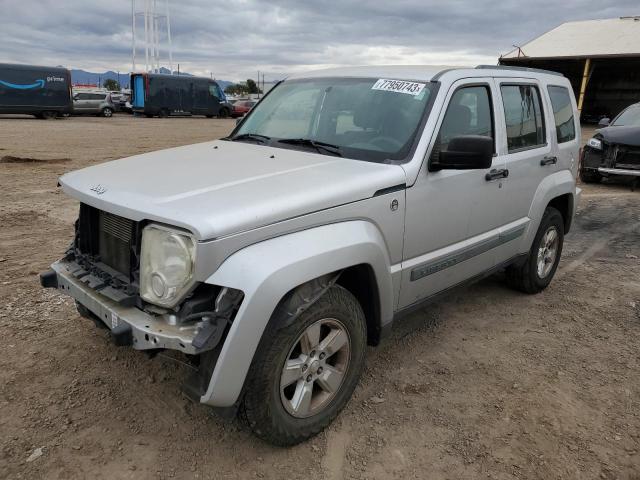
<box><xmin>230</xmin><ymin>78</ymin><xmax>434</xmax><ymax>162</ymax></box>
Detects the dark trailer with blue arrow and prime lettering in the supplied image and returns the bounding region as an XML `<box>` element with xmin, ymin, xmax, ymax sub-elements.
<box><xmin>0</xmin><ymin>63</ymin><xmax>73</xmax><ymax>118</ymax></box>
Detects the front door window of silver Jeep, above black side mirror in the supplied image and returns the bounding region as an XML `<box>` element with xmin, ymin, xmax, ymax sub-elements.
<box><xmin>432</xmin><ymin>85</ymin><xmax>494</xmax><ymax>158</ymax></box>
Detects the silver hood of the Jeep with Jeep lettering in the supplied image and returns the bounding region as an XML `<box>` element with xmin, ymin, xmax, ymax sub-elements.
<box><xmin>60</xmin><ymin>140</ymin><xmax>405</xmax><ymax>240</ymax></box>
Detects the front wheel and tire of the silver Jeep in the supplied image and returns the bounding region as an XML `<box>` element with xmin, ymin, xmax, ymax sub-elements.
<box><xmin>240</xmin><ymin>285</ymin><xmax>367</xmax><ymax>446</ymax></box>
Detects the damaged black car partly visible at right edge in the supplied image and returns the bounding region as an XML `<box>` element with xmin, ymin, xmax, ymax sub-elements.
<box><xmin>580</xmin><ymin>103</ymin><xmax>640</xmax><ymax>183</ymax></box>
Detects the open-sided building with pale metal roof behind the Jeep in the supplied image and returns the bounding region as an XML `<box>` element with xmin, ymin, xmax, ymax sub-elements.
<box><xmin>499</xmin><ymin>16</ymin><xmax>640</xmax><ymax>120</ymax></box>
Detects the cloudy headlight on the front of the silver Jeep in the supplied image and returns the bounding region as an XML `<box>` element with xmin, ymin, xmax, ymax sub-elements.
<box><xmin>140</xmin><ymin>225</ymin><xmax>196</xmax><ymax>308</ymax></box>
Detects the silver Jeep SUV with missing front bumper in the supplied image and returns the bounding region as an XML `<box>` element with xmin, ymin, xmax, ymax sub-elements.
<box><xmin>41</xmin><ymin>66</ymin><xmax>580</xmax><ymax>445</ymax></box>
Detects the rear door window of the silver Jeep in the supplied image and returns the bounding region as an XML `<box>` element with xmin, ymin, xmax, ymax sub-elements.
<box><xmin>500</xmin><ymin>85</ymin><xmax>546</xmax><ymax>153</ymax></box>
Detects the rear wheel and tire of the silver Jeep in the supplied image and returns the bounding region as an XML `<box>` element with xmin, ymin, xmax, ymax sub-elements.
<box><xmin>507</xmin><ymin>207</ymin><xmax>564</xmax><ymax>293</ymax></box>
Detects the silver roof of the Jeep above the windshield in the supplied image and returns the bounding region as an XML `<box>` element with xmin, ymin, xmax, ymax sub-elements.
<box><xmin>287</xmin><ymin>65</ymin><xmax>560</xmax><ymax>82</ymax></box>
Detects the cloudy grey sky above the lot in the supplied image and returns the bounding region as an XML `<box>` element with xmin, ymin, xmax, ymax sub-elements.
<box><xmin>0</xmin><ymin>0</ymin><xmax>640</xmax><ymax>80</ymax></box>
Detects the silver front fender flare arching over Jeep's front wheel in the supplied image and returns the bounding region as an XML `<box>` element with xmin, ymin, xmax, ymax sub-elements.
<box><xmin>200</xmin><ymin>220</ymin><xmax>393</xmax><ymax>407</ymax></box>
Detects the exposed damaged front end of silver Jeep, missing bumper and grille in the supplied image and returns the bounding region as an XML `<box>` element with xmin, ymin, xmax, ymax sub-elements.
<box><xmin>40</xmin><ymin>204</ymin><xmax>243</xmax><ymax>390</ymax></box>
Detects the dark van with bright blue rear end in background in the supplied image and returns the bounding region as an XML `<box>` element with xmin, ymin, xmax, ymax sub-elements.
<box><xmin>131</xmin><ymin>73</ymin><xmax>227</xmax><ymax>118</ymax></box>
